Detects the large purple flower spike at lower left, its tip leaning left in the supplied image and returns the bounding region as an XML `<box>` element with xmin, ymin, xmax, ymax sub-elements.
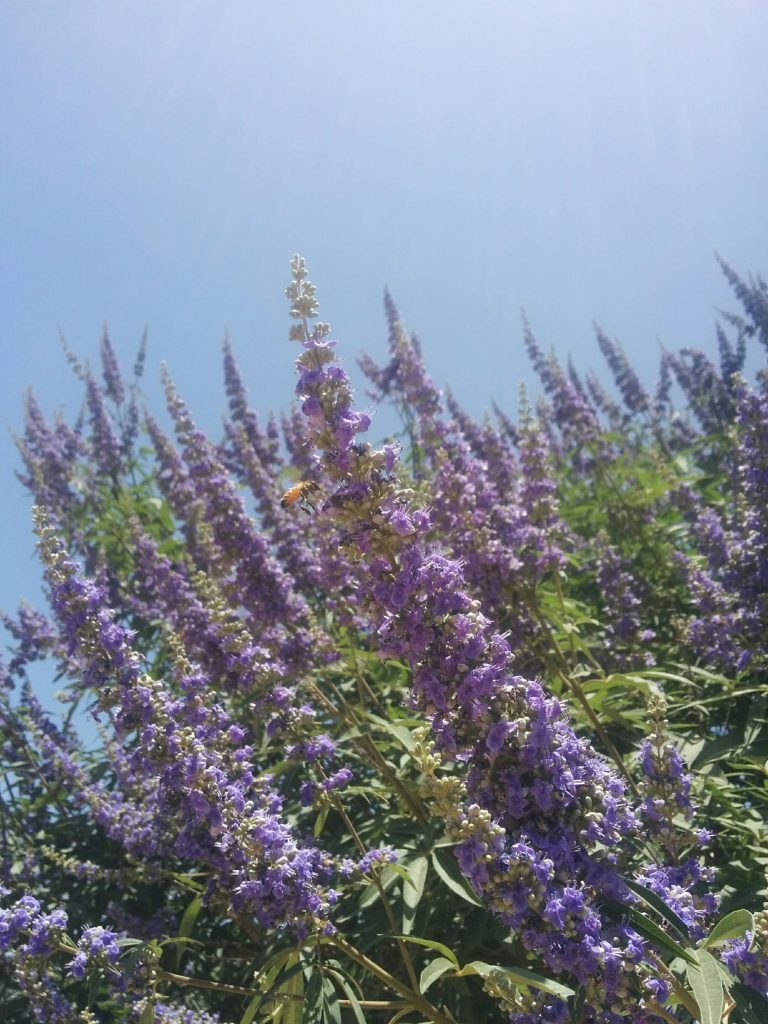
<box><xmin>30</xmin><ymin>513</ymin><xmax>336</xmax><ymax>931</ymax></box>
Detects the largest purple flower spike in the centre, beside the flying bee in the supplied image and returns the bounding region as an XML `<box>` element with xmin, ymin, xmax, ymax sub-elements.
<box><xmin>290</xmin><ymin>284</ymin><xmax>704</xmax><ymax>1021</ymax></box>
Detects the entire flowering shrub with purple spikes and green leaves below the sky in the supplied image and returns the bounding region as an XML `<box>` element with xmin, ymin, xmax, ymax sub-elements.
<box><xmin>0</xmin><ymin>257</ymin><xmax>768</xmax><ymax>1024</ymax></box>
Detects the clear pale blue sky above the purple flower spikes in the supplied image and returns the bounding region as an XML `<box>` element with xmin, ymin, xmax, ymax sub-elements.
<box><xmin>0</xmin><ymin>0</ymin><xmax>768</xmax><ymax>607</ymax></box>
